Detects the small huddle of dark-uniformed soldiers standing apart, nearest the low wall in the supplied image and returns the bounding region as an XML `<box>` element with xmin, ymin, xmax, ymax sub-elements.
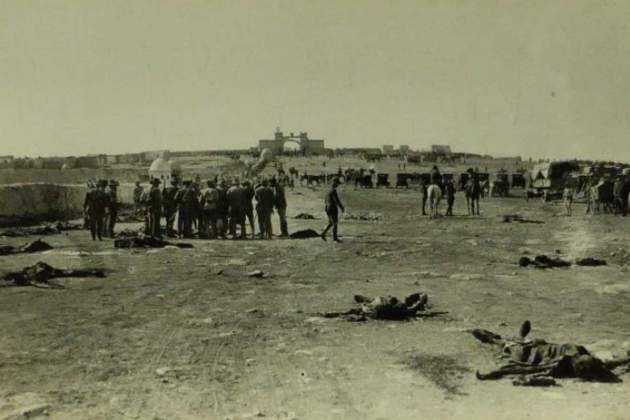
<box><xmin>83</xmin><ymin>179</ymin><xmax>120</xmax><ymax>241</ymax></box>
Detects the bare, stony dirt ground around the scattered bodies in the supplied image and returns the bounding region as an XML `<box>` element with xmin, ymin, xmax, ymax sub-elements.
<box><xmin>0</xmin><ymin>169</ymin><xmax>630</xmax><ymax>419</ymax></box>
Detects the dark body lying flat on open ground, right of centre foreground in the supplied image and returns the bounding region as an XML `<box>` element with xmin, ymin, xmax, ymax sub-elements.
<box><xmin>321</xmin><ymin>292</ymin><xmax>446</xmax><ymax>321</ymax></box>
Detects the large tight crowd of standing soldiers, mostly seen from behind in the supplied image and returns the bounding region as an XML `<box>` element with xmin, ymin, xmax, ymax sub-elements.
<box><xmin>134</xmin><ymin>177</ymin><xmax>289</xmax><ymax>239</ymax></box>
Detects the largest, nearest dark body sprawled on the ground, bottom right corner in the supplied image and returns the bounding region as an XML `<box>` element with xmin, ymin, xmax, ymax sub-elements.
<box><xmin>472</xmin><ymin>321</ymin><xmax>630</xmax><ymax>386</ymax></box>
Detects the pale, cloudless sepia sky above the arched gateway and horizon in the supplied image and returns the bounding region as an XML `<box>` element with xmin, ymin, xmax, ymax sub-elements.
<box><xmin>0</xmin><ymin>0</ymin><xmax>630</xmax><ymax>161</ymax></box>
